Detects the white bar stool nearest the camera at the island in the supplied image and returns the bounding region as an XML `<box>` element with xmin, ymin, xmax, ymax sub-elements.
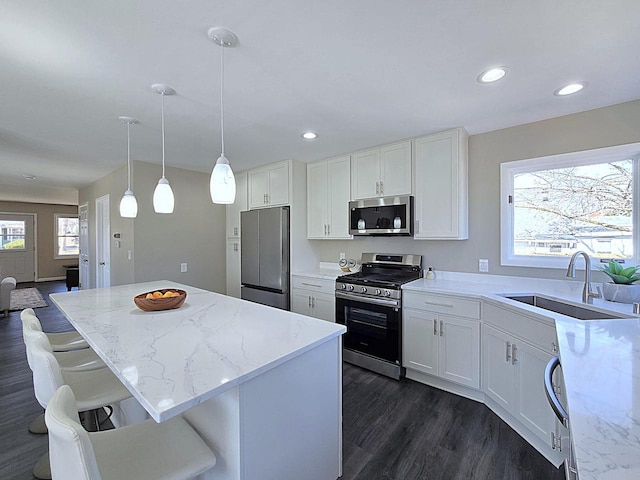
<box><xmin>45</xmin><ymin>386</ymin><xmax>216</xmax><ymax>480</ymax></box>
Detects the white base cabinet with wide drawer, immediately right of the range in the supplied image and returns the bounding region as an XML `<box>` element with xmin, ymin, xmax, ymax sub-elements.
<box><xmin>402</xmin><ymin>291</ymin><xmax>480</xmax><ymax>389</ymax></box>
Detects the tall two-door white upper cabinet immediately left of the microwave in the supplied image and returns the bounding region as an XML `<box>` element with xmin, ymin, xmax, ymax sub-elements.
<box><xmin>307</xmin><ymin>155</ymin><xmax>353</xmax><ymax>239</ymax></box>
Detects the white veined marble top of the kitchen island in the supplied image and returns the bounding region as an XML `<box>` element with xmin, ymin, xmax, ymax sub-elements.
<box><xmin>50</xmin><ymin>281</ymin><xmax>346</xmax><ymax>422</ymax></box>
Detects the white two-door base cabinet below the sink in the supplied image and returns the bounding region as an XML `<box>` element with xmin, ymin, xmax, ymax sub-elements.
<box><xmin>482</xmin><ymin>304</ymin><xmax>568</xmax><ymax>461</ymax></box>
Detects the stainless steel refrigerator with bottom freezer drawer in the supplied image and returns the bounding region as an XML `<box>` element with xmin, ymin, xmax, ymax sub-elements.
<box><xmin>240</xmin><ymin>207</ymin><xmax>289</xmax><ymax>310</ymax></box>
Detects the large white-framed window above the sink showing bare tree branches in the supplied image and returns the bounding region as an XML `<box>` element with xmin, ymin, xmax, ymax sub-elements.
<box><xmin>500</xmin><ymin>144</ymin><xmax>640</xmax><ymax>268</ymax></box>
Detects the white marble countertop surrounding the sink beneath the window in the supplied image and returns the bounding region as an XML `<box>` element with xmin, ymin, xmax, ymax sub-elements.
<box><xmin>403</xmin><ymin>272</ymin><xmax>640</xmax><ymax>480</ymax></box>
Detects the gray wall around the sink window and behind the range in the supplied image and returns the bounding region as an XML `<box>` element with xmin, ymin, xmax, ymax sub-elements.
<box><xmin>317</xmin><ymin>99</ymin><xmax>640</xmax><ymax>281</ymax></box>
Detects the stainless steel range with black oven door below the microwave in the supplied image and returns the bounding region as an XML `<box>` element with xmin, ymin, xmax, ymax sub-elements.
<box><xmin>336</xmin><ymin>253</ymin><xmax>422</xmax><ymax>379</ymax></box>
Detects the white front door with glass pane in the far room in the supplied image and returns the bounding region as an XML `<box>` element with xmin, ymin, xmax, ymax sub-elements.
<box><xmin>0</xmin><ymin>213</ymin><xmax>36</xmax><ymax>283</ymax></box>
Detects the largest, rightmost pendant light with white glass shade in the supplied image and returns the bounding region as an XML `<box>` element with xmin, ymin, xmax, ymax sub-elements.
<box><xmin>209</xmin><ymin>27</ymin><xmax>238</xmax><ymax>204</ymax></box>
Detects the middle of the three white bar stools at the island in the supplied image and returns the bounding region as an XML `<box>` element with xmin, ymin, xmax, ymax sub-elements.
<box><xmin>26</xmin><ymin>342</ymin><xmax>131</xmax><ymax>479</ymax></box>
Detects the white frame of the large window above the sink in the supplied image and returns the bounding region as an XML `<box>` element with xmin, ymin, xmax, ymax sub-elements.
<box><xmin>500</xmin><ymin>142</ymin><xmax>640</xmax><ymax>270</ymax></box>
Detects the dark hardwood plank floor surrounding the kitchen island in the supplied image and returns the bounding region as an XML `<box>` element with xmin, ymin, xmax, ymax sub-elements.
<box><xmin>0</xmin><ymin>281</ymin><xmax>564</xmax><ymax>480</ymax></box>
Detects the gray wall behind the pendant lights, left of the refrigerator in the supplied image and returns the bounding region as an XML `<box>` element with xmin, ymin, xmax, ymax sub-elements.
<box><xmin>79</xmin><ymin>161</ymin><xmax>226</xmax><ymax>293</ymax></box>
